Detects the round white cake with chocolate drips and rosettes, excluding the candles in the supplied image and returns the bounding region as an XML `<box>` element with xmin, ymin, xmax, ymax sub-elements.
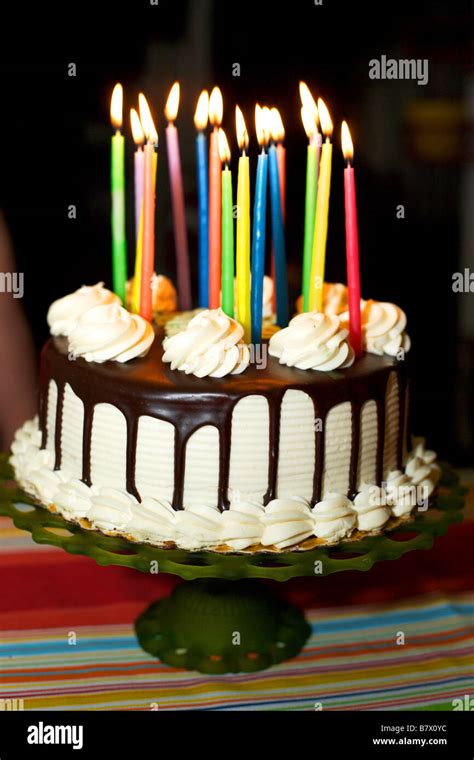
<box><xmin>8</xmin><ymin>284</ymin><xmax>439</xmax><ymax>551</ymax></box>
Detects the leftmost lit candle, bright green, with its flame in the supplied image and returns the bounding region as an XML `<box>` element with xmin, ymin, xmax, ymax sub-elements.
<box><xmin>110</xmin><ymin>84</ymin><xmax>127</xmax><ymax>303</ymax></box>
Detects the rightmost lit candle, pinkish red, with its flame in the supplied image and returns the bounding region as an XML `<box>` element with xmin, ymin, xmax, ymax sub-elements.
<box><xmin>341</xmin><ymin>121</ymin><xmax>362</xmax><ymax>356</ymax></box>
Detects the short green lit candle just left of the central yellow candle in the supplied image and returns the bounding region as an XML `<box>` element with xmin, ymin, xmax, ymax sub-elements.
<box><xmin>219</xmin><ymin>129</ymin><xmax>234</xmax><ymax>317</ymax></box>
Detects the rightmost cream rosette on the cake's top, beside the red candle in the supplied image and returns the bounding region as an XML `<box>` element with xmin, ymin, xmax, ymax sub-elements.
<box><xmin>361</xmin><ymin>300</ymin><xmax>411</xmax><ymax>356</ymax></box>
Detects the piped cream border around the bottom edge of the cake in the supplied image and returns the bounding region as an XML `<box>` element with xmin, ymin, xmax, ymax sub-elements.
<box><xmin>10</xmin><ymin>417</ymin><xmax>441</xmax><ymax>552</ymax></box>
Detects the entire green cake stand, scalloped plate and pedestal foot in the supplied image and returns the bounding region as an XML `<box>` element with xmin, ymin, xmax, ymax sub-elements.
<box><xmin>0</xmin><ymin>456</ymin><xmax>467</xmax><ymax>674</ymax></box>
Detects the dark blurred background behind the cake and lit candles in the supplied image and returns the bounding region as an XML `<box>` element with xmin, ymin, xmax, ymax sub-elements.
<box><xmin>0</xmin><ymin>0</ymin><xmax>474</xmax><ymax>464</ymax></box>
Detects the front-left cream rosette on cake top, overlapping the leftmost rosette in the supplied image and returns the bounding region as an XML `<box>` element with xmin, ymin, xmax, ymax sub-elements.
<box><xmin>69</xmin><ymin>303</ymin><xmax>155</xmax><ymax>363</ymax></box>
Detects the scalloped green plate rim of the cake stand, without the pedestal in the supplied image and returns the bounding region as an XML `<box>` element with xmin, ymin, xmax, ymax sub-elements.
<box><xmin>0</xmin><ymin>455</ymin><xmax>468</xmax><ymax>581</ymax></box>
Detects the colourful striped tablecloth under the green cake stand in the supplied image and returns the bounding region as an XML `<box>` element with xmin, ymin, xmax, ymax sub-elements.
<box><xmin>0</xmin><ymin>490</ymin><xmax>474</xmax><ymax>710</ymax></box>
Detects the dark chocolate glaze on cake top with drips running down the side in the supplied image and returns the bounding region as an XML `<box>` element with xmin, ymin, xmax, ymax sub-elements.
<box><xmin>40</xmin><ymin>328</ymin><xmax>407</xmax><ymax>509</ymax></box>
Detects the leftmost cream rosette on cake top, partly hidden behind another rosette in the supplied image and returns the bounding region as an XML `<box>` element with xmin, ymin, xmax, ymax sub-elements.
<box><xmin>46</xmin><ymin>282</ymin><xmax>121</xmax><ymax>337</ymax></box>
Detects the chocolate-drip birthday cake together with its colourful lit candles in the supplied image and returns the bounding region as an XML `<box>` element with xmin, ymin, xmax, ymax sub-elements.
<box><xmin>7</xmin><ymin>80</ymin><xmax>440</xmax><ymax>552</ymax></box>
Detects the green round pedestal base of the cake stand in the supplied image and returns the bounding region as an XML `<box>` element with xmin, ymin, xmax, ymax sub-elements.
<box><xmin>135</xmin><ymin>579</ymin><xmax>310</xmax><ymax>674</ymax></box>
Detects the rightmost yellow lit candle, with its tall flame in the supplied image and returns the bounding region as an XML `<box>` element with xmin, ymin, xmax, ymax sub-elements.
<box><xmin>300</xmin><ymin>82</ymin><xmax>322</xmax><ymax>311</ymax></box>
